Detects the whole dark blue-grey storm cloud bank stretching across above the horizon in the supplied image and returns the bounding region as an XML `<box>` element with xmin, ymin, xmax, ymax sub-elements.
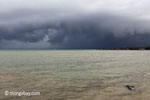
<box><xmin>0</xmin><ymin>14</ymin><xmax>150</xmax><ymax>48</ymax></box>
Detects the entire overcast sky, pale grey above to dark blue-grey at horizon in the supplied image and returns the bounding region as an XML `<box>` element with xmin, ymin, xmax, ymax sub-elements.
<box><xmin>0</xmin><ymin>0</ymin><xmax>150</xmax><ymax>49</ymax></box>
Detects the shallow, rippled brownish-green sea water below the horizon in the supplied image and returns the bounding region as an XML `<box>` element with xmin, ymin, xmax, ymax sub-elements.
<box><xmin>0</xmin><ymin>50</ymin><xmax>150</xmax><ymax>100</ymax></box>
